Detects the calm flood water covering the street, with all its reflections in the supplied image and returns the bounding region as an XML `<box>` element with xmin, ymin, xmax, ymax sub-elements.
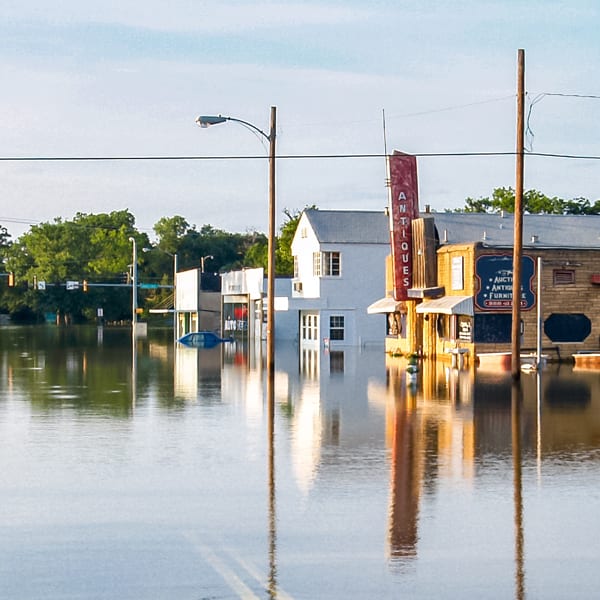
<box><xmin>0</xmin><ymin>327</ymin><xmax>600</xmax><ymax>600</ymax></box>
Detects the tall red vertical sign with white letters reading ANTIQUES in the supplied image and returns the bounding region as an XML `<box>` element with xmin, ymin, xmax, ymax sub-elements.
<box><xmin>387</xmin><ymin>151</ymin><xmax>419</xmax><ymax>300</ymax></box>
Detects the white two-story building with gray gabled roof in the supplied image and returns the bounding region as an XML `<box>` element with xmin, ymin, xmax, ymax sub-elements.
<box><xmin>290</xmin><ymin>209</ymin><xmax>390</xmax><ymax>348</ymax></box>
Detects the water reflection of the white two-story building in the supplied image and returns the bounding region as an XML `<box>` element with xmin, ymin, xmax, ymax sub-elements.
<box><xmin>292</xmin><ymin>347</ymin><xmax>385</xmax><ymax>495</ymax></box>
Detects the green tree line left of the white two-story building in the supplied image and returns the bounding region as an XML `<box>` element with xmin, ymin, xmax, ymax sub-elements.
<box><xmin>0</xmin><ymin>210</ymin><xmax>300</xmax><ymax>323</ymax></box>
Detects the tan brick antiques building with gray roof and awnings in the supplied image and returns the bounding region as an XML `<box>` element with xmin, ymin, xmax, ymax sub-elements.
<box><xmin>374</xmin><ymin>213</ymin><xmax>600</xmax><ymax>359</ymax></box>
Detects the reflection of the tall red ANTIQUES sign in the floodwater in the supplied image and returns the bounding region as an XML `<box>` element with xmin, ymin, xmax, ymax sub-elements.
<box><xmin>389</xmin><ymin>366</ymin><xmax>421</xmax><ymax>562</ymax></box>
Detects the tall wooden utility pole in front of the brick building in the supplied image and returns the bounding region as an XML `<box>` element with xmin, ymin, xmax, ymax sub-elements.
<box><xmin>511</xmin><ymin>49</ymin><xmax>525</xmax><ymax>381</ymax></box>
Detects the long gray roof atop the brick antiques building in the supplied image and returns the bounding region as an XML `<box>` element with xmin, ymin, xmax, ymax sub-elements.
<box><xmin>428</xmin><ymin>213</ymin><xmax>600</xmax><ymax>249</ymax></box>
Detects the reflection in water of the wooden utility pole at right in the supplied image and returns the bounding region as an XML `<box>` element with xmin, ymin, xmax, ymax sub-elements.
<box><xmin>511</xmin><ymin>381</ymin><xmax>525</xmax><ymax>600</ymax></box>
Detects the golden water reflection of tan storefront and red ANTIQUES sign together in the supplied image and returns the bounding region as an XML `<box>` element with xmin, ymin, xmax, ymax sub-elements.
<box><xmin>386</xmin><ymin>359</ymin><xmax>475</xmax><ymax>565</ymax></box>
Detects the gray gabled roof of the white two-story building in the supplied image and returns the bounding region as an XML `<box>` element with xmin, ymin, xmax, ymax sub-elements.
<box><xmin>304</xmin><ymin>208</ymin><xmax>390</xmax><ymax>244</ymax></box>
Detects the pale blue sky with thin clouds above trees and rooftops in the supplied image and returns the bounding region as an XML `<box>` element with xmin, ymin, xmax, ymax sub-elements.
<box><xmin>0</xmin><ymin>0</ymin><xmax>600</xmax><ymax>236</ymax></box>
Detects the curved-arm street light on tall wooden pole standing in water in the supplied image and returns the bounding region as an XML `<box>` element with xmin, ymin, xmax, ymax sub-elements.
<box><xmin>196</xmin><ymin>106</ymin><xmax>277</xmax><ymax>378</ymax></box>
